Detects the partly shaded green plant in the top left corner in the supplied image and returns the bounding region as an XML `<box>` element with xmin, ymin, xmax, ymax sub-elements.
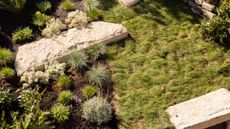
<box><xmin>0</xmin><ymin>0</ymin><xmax>27</xmax><ymax>13</ymax></box>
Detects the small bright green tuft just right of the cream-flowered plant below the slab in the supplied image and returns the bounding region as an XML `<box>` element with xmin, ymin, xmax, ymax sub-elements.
<box><xmin>57</xmin><ymin>76</ymin><xmax>72</xmax><ymax>89</ymax></box>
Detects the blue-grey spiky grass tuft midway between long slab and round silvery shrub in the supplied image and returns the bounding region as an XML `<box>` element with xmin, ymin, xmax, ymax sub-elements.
<box><xmin>87</xmin><ymin>65</ymin><xmax>110</xmax><ymax>88</ymax></box>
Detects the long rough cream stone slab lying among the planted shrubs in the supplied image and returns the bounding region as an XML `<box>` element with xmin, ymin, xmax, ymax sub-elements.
<box><xmin>15</xmin><ymin>21</ymin><xmax>128</xmax><ymax>75</ymax></box>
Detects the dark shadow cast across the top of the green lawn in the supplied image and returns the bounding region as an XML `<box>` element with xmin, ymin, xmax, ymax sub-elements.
<box><xmin>133</xmin><ymin>0</ymin><xmax>200</xmax><ymax>25</ymax></box>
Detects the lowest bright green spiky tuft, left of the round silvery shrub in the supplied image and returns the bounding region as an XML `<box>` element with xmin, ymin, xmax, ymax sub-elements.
<box><xmin>51</xmin><ymin>103</ymin><xmax>70</xmax><ymax>123</ymax></box>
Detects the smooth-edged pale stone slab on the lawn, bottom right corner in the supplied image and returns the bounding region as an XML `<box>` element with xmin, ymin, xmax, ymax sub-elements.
<box><xmin>166</xmin><ymin>88</ymin><xmax>230</xmax><ymax>129</ymax></box>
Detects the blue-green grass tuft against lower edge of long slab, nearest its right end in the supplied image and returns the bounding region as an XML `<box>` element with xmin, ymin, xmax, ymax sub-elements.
<box><xmin>86</xmin><ymin>43</ymin><xmax>107</xmax><ymax>61</ymax></box>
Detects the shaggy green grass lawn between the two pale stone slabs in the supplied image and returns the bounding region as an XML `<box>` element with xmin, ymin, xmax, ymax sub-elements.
<box><xmin>102</xmin><ymin>0</ymin><xmax>230</xmax><ymax>129</ymax></box>
